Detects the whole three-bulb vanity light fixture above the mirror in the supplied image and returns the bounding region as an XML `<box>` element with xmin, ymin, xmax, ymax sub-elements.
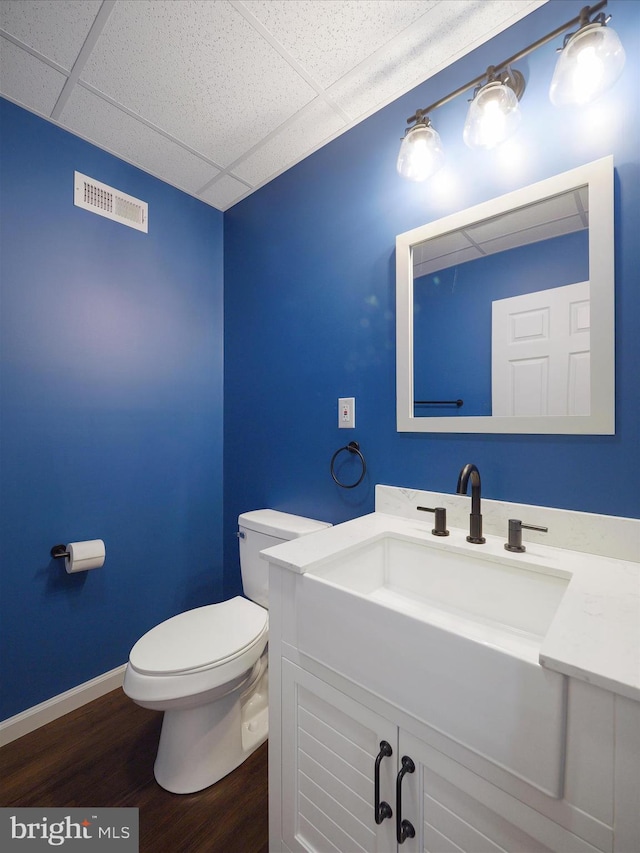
<box><xmin>396</xmin><ymin>0</ymin><xmax>625</xmax><ymax>181</ymax></box>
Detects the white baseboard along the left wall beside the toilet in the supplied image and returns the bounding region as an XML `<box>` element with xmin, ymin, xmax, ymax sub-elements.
<box><xmin>0</xmin><ymin>663</ymin><xmax>127</xmax><ymax>746</ymax></box>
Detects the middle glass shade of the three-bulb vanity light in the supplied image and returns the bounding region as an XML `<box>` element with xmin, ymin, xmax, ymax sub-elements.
<box><xmin>463</xmin><ymin>80</ymin><xmax>520</xmax><ymax>148</ymax></box>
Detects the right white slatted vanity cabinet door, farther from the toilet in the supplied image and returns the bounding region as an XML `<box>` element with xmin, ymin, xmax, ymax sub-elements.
<box><xmin>398</xmin><ymin>729</ymin><xmax>596</xmax><ymax>853</ymax></box>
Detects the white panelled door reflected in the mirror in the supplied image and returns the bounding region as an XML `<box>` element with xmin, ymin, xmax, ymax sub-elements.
<box><xmin>491</xmin><ymin>281</ymin><xmax>591</xmax><ymax>417</ymax></box>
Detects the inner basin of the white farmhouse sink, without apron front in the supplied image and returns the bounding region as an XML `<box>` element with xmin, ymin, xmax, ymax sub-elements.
<box><xmin>309</xmin><ymin>534</ymin><xmax>571</xmax><ymax>663</ymax></box>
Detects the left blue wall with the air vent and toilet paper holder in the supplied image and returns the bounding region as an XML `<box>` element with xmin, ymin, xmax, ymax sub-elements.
<box><xmin>0</xmin><ymin>101</ymin><xmax>223</xmax><ymax>718</ymax></box>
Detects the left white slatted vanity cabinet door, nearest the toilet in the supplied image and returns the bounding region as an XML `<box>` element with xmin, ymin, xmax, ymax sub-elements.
<box><xmin>282</xmin><ymin>660</ymin><xmax>398</xmax><ymax>853</ymax></box>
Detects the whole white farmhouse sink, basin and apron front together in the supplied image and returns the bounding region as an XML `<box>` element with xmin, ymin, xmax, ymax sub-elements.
<box><xmin>295</xmin><ymin>533</ymin><xmax>570</xmax><ymax>797</ymax></box>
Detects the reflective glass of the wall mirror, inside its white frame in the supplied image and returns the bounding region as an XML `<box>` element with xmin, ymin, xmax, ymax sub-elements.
<box><xmin>413</xmin><ymin>187</ymin><xmax>590</xmax><ymax>417</ymax></box>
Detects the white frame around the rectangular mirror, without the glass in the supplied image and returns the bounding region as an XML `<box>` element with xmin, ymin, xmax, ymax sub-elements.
<box><xmin>396</xmin><ymin>156</ymin><xmax>615</xmax><ymax>435</ymax></box>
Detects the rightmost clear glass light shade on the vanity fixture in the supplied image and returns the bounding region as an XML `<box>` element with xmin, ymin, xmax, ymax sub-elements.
<box><xmin>549</xmin><ymin>24</ymin><xmax>625</xmax><ymax>106</ymax></box>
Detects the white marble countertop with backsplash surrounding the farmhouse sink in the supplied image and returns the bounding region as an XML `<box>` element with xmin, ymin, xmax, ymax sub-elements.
<box><xmin>263</xmin><ymin>486</ymin><xmax>640</xmax><ymax>701</ymax></box>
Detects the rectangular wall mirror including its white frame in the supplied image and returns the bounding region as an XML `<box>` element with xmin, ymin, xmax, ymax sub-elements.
<box><xmin>396</xmin><ymin>157</ymin><xmax>615</xmax><ymax>435</ymax></box>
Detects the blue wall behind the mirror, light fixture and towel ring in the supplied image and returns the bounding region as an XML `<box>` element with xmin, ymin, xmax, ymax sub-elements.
<box><xmin>224</xmin><ymin>0</ymin><xmax>640</xmax><ymax>592</ymax></box>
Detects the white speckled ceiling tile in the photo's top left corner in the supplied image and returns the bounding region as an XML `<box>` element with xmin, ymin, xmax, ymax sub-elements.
<box><xmin>0</xmin><ymin>0</ymin><xmax>101</xmax><ymax>71</ymax></box>
